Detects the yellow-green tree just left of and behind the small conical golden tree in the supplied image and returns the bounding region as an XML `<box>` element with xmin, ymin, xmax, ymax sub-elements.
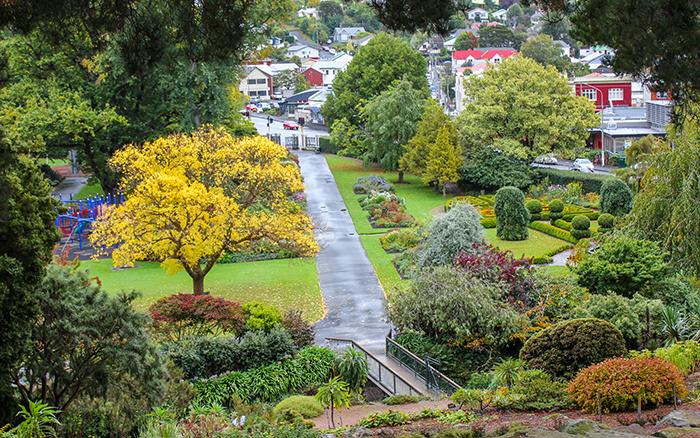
<box><xmin>399</xmin><ymin>100</ymin><xmax>452</xmax><ymax>177</ymax></box>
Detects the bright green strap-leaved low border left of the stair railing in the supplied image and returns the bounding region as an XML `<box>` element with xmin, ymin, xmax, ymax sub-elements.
<box><xmin>192</xmin><ymin>347</ymin><xmax>335</xmax><ymax>406</ymax></box>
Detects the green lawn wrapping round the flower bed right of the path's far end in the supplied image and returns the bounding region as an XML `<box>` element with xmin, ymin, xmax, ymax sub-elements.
<box><xmin>326</xmin><ymin>155</ymin><xmax>452</xmax><ymax>234</ymax></box>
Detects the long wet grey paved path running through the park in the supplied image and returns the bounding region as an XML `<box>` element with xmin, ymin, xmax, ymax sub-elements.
<box><xmin>298</xmin><ymin>151</ymin><xmax>389</xmax><ymax>354</ymax></box>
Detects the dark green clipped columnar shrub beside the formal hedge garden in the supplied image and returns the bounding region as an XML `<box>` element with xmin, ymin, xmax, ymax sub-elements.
<box><xmin>494</xmin><ymin>186</ymin><xmax>530</xmax><ymax>240</ymax></box>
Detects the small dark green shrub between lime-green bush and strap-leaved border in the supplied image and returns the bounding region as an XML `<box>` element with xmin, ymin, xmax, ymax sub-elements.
<box><xmin>241</xmin><ymin>329</ymin><xmax>296</xmax><ymax>370</ymax></box>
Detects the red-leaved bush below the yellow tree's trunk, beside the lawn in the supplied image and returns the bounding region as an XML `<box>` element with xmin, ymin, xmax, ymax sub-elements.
<box><xmin>149</xmin><ymin>294</ymin><xmax>246</xmax><ymax>341</ymax></box>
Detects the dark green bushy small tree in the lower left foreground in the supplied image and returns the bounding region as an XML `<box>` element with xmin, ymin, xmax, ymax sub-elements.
<box><xmin>11</xmin><ymin>263</ymin><xmax>162</xmax><ymax>411</ymax></box>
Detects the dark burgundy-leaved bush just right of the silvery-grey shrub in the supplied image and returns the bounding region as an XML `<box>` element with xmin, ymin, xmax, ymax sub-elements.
<box><xmin>455</xmin><ymin>242</ymin><xmax>534</xmax><ymax>306</ymax></box>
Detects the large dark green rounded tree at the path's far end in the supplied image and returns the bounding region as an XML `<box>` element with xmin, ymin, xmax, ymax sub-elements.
<box><xmin>323</xmin><ymin>32</ymin><xmax>428</xmax><ymax>126</ymax></box>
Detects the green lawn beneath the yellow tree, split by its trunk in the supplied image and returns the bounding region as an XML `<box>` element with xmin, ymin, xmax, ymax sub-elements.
<box><xmin>82</xmin><ymin>259</ymin><xmax>323</xmax><ymax>321</ymax></box>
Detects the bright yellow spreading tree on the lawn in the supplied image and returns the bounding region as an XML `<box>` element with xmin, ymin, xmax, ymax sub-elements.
<box><xmin>90</xmin><ymin>128</ymin><xmax>318</xmax><ymax>295</ymax></box>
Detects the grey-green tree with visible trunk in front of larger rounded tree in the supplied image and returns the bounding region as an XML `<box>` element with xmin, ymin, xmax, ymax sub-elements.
<box><xmin>360</xmin><ymin>77</ymin><xmax>428</xmax><ymax>184</ymax></box>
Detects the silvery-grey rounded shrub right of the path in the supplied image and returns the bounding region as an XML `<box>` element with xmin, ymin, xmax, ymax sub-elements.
<box><xmin>416</xmin><ymin>203</ymin><xmax>485</xmax><ymax>269</ymax></box>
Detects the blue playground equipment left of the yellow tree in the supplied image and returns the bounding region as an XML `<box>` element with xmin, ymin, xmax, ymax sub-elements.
<box><xmin>56</xmin><ymin>194</ymin><xmax>124</xmax><ymax>252</ymax></box>
